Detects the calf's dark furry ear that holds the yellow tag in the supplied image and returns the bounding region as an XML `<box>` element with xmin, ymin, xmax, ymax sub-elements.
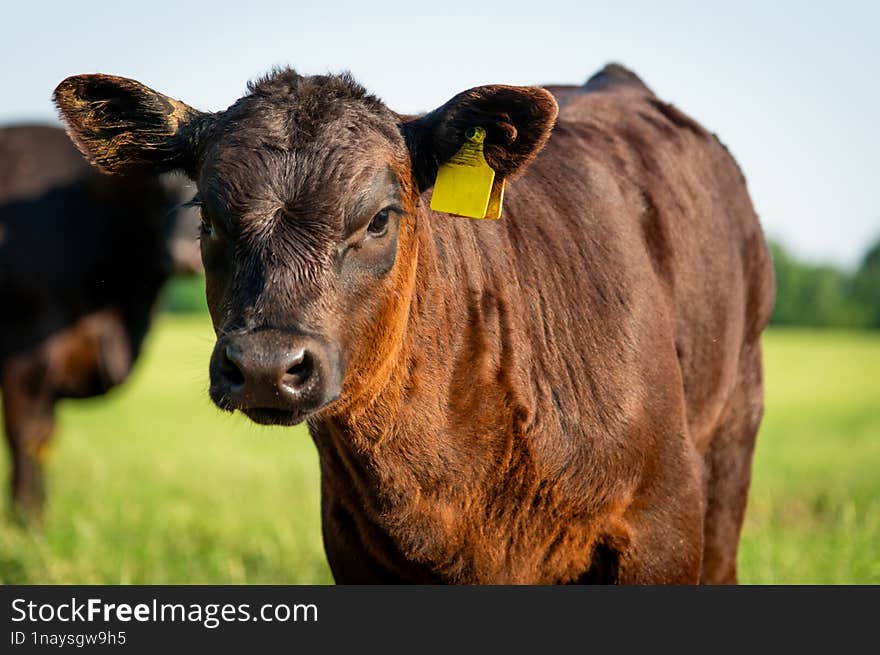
<box><xmin>401</xmin><ymin>84</ymin><xmax>559</xmax><ymax>191</ymax></box>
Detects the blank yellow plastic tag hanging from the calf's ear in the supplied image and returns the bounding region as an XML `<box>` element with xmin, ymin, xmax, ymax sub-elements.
<box><xmin>431</xmin><ymin>127</ymin><xmax>504</xmax><ymax>218</ymax></box>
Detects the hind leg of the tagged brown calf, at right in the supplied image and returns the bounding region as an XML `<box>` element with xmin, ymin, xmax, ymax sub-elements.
<box><xmin>700</xmin><ymin>342</ymin><xmax>764</xmax><ymax>584</ymax></box>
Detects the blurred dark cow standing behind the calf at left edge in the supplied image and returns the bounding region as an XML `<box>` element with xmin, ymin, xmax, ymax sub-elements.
<box><xmin>0</xmin><ymin>125</ymin><xmax>198</xmax><ymax>512</ymax></box>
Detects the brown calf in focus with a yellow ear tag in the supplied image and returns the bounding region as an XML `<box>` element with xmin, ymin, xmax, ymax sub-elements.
<box><xmin>55</xmin><ymin>66</ymin><xmax>773</xmax><ymax>583</ymax></box>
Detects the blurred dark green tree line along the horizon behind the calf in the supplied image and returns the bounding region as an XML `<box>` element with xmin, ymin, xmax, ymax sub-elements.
<box><xmin>161</xmin><ymin>239</ymin><xmax>880</xmax><ymax>329</ymax></box>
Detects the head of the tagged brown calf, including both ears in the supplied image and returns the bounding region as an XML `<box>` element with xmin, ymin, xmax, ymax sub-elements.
<box><xmin>54</xmin><ymin>69</ymin><xmax>556</xmax><ymax>424</ymax></box>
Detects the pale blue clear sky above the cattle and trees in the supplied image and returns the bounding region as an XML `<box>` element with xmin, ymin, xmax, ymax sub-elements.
<box><xmin>0</xmin><ymin>0</ymin><xmax>880</xmax><ymax>266</ymax></box>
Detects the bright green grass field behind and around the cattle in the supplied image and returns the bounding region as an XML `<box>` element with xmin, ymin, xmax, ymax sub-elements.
<box><xmin>0</xmin><ymin>315</ymin><xmax>880</xmax><ymax>584</ymax></box>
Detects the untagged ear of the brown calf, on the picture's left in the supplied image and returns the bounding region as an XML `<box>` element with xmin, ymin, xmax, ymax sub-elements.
<box><xmin>52</xmin><ymin>74</ymin><xmax>210</xmax><ymax>176</ymax></box>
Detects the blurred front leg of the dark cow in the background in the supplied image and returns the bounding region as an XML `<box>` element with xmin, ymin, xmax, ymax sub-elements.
<box><xmin>2</xmin><ymin>354</ymin><xmax>55</xmax><ymax>517</ymax></box>
